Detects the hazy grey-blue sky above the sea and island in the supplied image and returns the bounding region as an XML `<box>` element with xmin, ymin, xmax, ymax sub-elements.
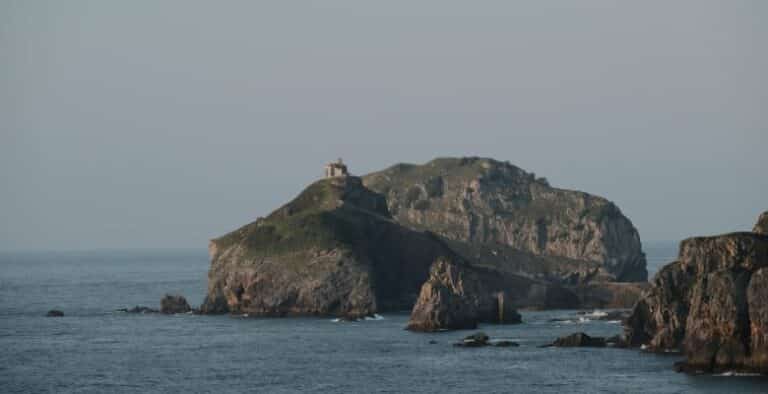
<box><xmin>0</xmin><ymin>0</ymin><xmax>768</xmax><ymax>250</ymax></box>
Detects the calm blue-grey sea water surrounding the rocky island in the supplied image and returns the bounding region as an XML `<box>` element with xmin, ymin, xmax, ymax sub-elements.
<box><xmin>0</xmin><ymin>243</ymin><xmax>768</xmax><ymax>393</ymax></box>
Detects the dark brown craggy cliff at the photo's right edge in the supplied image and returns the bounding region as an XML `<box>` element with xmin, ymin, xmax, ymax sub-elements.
<box><xmin>627</xmin><ymin>214</ymin><xmax>768</xmax><ymax>373</ymax></box>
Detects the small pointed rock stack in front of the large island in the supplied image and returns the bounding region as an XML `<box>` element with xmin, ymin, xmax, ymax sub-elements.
<box><xmin>407</xmin><ymin>258</ymin><xmax>521</xmax><ymax>331</ymax></box>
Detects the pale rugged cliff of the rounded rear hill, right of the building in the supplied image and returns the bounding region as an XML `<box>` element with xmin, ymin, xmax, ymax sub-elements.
<box><xmin>363</xmin><ymin>158</ymin><xmax>647</xmax><ymax>281</ymax></box>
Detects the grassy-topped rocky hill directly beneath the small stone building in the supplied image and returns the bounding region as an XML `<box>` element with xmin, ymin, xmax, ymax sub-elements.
<box><xmin>201</xmin><ymin>176</ymin><xmax>468</xmax><ymax>318</ymax></box>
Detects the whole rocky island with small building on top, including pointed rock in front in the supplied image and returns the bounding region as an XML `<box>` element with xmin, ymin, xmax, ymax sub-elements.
<box><xmin>201</xmin><ymin>158</ymin><xmax>647</xmax><ymax>331</ymax></box>
